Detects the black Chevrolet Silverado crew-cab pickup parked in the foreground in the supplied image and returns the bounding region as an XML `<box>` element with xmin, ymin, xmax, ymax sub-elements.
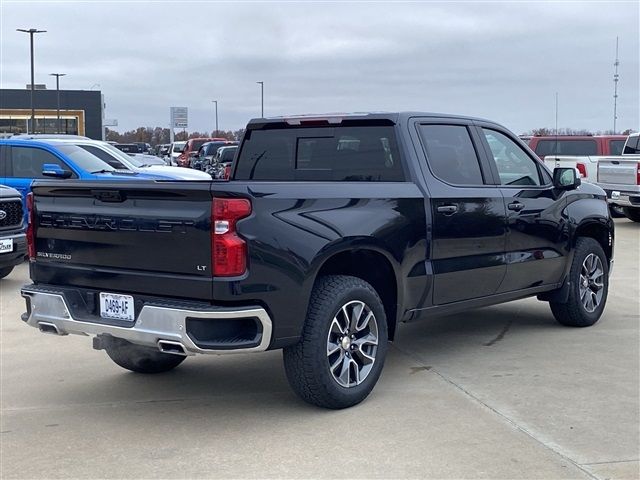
<box><xmin>22</xmin><ymin>113</ymin><xmax>614</xmax><ymax>408</ymax></box>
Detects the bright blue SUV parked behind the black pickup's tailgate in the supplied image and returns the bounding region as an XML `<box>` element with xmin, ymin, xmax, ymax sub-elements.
<box><xmin>0</xmin><ymin>139</ymin><xmax>167</xmax><ymax>211</ymax></box>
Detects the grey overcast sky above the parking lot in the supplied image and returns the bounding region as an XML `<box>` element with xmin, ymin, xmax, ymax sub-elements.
<box><xmin>0</xmin><ymin>0</ymin><xmax>640</xmax><ymax>133</ymax></box>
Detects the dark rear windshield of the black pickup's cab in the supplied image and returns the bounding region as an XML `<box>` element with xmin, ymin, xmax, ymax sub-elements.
<box><xmin>235</xmin><ymin>126</ymin><xmax>404</xmax><ymax>182</ymax></box>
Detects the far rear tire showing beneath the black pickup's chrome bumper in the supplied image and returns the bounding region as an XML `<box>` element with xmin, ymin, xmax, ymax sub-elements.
<box><xmin>105</xmin><ymin>337</ymin><xmax>186</xmax><ymax>373</ymax></box>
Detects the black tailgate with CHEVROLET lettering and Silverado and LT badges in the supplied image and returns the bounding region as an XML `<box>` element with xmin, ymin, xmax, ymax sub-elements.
<box><xmin>32</xmin><ymin>181</ymin><xmax>212</xmax><ymax>300</ymax></box>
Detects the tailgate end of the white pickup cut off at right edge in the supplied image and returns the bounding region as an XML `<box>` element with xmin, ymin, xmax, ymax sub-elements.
<box><xmin>596</xmin><ymin>155</ymin><xmax>640</xmax><ymax>222</ymax></box>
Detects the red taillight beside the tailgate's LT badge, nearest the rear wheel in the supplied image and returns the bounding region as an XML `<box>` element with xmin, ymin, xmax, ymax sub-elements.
<box><xmin>211</xmin><ymin>198</ymin><xmax>251</xmax><ymax>277</ymax></box>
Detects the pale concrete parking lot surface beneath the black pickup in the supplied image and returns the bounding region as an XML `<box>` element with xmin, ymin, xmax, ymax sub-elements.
<box><xmin>0</xmin><ymin>219</ymin><xmax>640</xmax><ymax>479</ymax></box>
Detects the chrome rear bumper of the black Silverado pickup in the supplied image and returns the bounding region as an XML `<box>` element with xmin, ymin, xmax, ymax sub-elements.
<box><xmin>21</xmin><ymin>285</ymin><xmax>272</xmax><ymax>355</ymax></box>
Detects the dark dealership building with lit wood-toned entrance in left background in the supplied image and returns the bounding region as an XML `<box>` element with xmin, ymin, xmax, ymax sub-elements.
<box><xmin>0</xmin><ymin>85</ymin><xmax>104</xmax><ymax>140</ymax></box>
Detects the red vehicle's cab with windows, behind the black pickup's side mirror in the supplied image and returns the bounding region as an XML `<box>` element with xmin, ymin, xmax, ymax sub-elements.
<box><xmin>529</xmin><ymin>135</ymin><xmax>627</xmax><ymax>160</ymax></box>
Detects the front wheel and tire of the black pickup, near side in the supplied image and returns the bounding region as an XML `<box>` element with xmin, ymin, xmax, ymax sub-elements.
<box><xmin>549</xmin><ymin>237</ymin><xmax>609</xmax><ymax>327</ymax></box>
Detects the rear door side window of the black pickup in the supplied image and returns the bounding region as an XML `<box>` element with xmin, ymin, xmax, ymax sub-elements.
<box><xmin>419</xmin><ymin>125</ymin><xmax>484</xmax><ymax>185</ymax></box>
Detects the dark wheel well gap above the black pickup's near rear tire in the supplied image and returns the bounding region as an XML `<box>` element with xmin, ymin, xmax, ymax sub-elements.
<box><xmin>313</xmin><ymin>246</ymin><xmax>402</xmax><ymax>340</ymax></box>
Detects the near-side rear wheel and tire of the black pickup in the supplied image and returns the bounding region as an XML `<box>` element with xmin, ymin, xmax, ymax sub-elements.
<box><xmin>283</xmin><ymin>275</ymin><xmax>387</xmax><ymax>409</ymax></box>
